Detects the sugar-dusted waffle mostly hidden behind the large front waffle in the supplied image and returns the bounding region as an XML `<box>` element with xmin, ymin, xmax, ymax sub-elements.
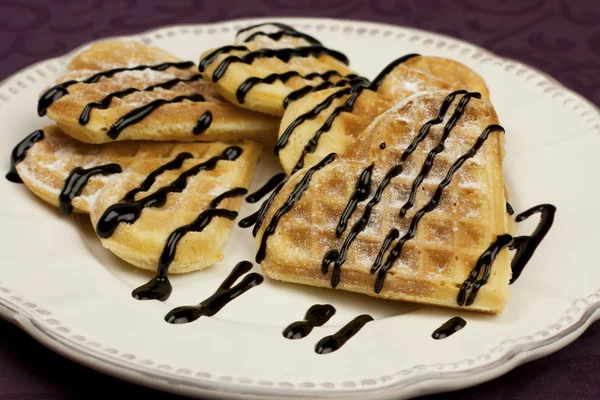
<box><xmin>276</xmin><ymin>55</ymin><xmax>489</xmax><ymax>174</ymax></box>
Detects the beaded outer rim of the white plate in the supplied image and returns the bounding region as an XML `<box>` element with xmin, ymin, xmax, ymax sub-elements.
<box><xmin>0</xmin><ymin>17</ymin><xmax>600</xmax><ymax>398</ymax></box>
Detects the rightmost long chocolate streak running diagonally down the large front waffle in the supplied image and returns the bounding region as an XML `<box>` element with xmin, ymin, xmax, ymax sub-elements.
<box><xmin>375</xmin><ymin>125</ymin><xmax>504</xmax><ymax>293</ymax></box>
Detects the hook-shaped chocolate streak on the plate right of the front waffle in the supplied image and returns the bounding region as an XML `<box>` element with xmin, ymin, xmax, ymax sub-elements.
<box><xmin>510</xmin><ymin>204</ymin><xmax>556</xmax><ymax>284</ymax></box>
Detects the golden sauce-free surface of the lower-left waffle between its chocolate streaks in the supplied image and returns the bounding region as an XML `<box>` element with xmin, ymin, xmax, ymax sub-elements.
<box><xmin>17</xmin><ymin>126</ymin><xmax>260</xmax><ymax>273</ymax></box>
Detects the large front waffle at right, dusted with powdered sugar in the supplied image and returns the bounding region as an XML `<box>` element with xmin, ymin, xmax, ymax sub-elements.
<box><xmin>257</xmin><ymin>91</ymin><xmax>512</xmax><ymax>313</ymax></box>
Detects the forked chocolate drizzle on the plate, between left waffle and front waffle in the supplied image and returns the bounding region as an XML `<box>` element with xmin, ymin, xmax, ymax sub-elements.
<box><xmin>165</xmin><ymin>261</ymin><xmax>264</xmax><ymax>324</ymax></box>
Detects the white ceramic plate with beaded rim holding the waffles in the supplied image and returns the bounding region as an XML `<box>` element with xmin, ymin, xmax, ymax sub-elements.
<box><xmin>0</xmin><ymin>19</ymin><xmax>600</xmax><ymax>399</ymax></box>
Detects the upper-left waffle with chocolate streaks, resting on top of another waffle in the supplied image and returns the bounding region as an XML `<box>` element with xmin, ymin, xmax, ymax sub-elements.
<box><xmin>38</xmin><ymin>41</ymin><xmax>278</xmax><ymax>143</ymax></box>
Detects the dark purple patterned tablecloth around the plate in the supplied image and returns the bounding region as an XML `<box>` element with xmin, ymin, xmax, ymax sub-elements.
<box><xmin>0</xmin><ymin>0</ymin><xmax>600</xmax><ymax>400</ymax></box>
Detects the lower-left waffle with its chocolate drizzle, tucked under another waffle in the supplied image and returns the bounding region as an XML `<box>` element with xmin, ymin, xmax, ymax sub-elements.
<box><xmin>13</xmin><ymin>125</ymin><xmax>261</xmax><ymax>286</ymax></box>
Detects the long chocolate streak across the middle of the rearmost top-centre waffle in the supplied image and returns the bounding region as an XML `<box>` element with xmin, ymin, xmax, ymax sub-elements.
<box><xmin>209</xmin><ymin>46</ymin><xmax>349</xmax><ymax>82</ymax></box>
